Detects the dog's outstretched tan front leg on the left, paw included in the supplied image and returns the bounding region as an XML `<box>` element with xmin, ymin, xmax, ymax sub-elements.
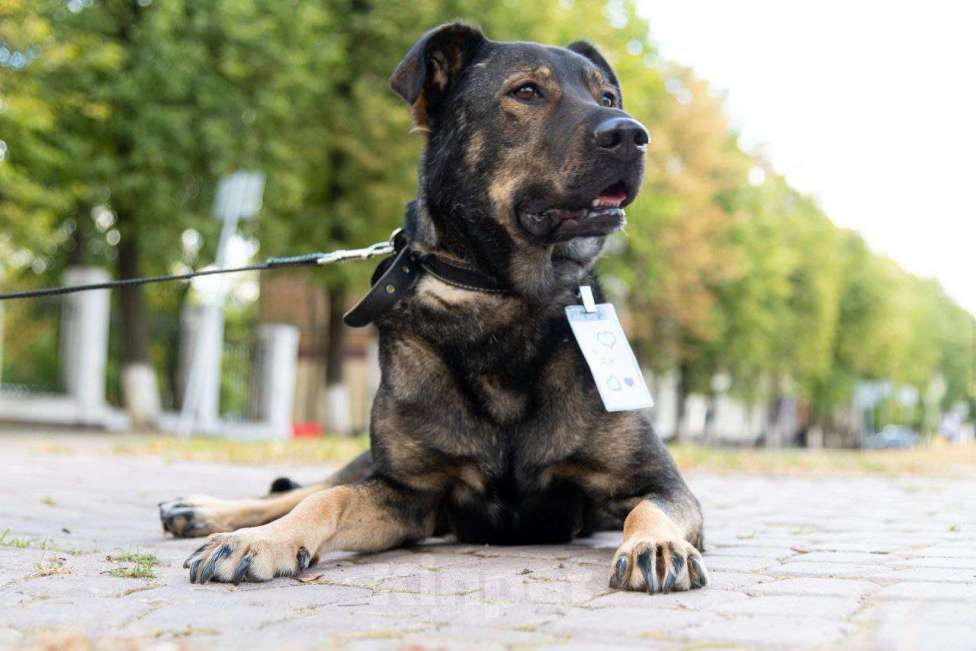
<box><xmin>184</xmin><ymin>478</ymin><xmax>436</xmax><ymax>583</ymax></box>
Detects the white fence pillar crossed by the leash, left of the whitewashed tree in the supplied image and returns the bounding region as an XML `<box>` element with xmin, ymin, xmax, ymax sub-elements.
<box><xmin>61</xmin><ymin>267</ymin><xmax>111</xmax><ymax>418</ymax></box>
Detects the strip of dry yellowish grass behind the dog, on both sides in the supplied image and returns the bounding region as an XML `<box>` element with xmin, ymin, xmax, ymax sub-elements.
<box><xmin>112</xmin><ymin>434</ymin><xmax>976</xmax><ymax>477</ymax></box>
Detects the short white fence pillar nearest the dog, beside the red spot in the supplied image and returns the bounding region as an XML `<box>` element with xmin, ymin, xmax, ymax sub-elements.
<box><xmin>255</xmin><ymin>323</ymin><xmax>299</xmax><ymax>439</ymax></box>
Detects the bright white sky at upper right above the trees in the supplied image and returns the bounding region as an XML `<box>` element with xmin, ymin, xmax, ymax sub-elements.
<box><xmin>638</xmin><ymin>0</ymin><xmax>976</xmax><ymax>313</ymax></box>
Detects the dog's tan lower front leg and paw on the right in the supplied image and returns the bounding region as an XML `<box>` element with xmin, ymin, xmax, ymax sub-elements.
<box><xmin>610</xmin><ymin>491</ymin><xmax>708</xmax><ymax>594</ymax></box>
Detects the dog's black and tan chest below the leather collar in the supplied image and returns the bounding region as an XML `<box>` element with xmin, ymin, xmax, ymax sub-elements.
<box><xmin>373</xmin><ymin>296</ymin><xmax>606</xmax><ymax>500</ymax></box>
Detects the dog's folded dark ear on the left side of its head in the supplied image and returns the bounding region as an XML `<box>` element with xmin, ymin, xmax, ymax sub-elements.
<box><xmin>390</xmin><ymin>23</ymin><xmax>487</xmax><ymax>129</ymax></box>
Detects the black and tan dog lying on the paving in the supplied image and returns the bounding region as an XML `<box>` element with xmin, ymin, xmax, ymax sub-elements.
<box><xmin>160</xmin><ymin>24</ymin><xmax>708</xmax><ymax>593</ymax></box>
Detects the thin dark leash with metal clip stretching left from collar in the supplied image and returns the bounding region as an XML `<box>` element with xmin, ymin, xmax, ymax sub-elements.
<box><xmin>0</xmin><ymin>237</ymin><xmax>400</xmax><ymax>301</ymax></box>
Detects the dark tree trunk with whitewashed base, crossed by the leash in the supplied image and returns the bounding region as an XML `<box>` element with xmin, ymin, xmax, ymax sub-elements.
<box><xmin>118</xmin><ymin>229</ymin><xmax>160</xmax><ymax>428</ymax></box>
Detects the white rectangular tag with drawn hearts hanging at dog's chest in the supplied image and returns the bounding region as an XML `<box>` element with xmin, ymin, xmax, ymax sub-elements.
<box><xmin>566</xmin><ymin>303</ymin><xmax>654</xmax><ymax>411</ymax></box>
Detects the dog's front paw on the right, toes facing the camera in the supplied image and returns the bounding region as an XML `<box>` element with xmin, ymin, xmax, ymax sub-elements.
<box><xmin>610</xmin><ymin>536</ymin><xmax>708</xmax><ymax>594</ymax></box>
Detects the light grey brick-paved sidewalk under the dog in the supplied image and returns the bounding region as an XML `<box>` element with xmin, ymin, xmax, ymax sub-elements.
<box><xmin>0</xmin><ymin>437</ymin><xmax>976</xmax><ymax>650</ymax></box>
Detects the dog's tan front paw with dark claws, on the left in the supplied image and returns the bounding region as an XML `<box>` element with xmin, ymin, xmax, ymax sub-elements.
<box><xmin>183</xmin><ymin>525</ymin><xmax>315</xmax><ymax>585</ymax></box>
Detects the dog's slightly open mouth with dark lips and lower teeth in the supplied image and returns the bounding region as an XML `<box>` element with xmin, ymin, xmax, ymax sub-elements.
<box><xmin>519</xmin><ymin>181</ymin><xmax>631</xmax><ymax>243</ymax></box>
